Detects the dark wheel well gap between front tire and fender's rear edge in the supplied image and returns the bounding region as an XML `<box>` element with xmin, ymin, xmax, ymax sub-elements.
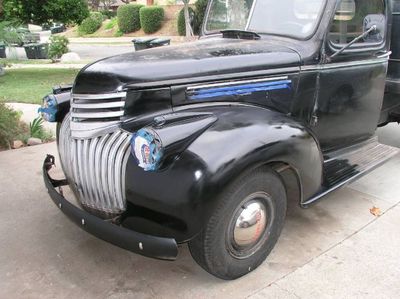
<box><xmin>266</xmin><ymin>162</ymin><xmax>302</xmax><ymax>204</ymax></box>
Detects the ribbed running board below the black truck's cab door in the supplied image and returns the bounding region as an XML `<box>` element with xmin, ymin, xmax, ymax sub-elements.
<box><xmin>301</xmin><ymin>137</ymin><xmax>400</xmax><ymax>208</ymax></box>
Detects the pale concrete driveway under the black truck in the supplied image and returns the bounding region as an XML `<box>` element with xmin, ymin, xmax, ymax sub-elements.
<box><xmin>0</xmin><ymin>124</ymin><xmax>400</xmax><ymax>299</ymax></box>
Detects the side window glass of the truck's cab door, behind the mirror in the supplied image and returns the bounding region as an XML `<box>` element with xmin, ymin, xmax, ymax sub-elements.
<box><xmin>329</xmin><ymin>0</ymin><xmax>386</xmax><ymax>47</ymax></box>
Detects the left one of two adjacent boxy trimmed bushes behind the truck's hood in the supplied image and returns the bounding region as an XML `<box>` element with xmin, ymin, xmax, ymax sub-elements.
<box><xmin>117</xmin><ymin>4</ymin><xmax>143</xmax><ymax>33</ymax></box>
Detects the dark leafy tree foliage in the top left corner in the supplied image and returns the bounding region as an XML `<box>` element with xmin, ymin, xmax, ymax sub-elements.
<box><xmin>2</xmin><ymin>0</ymin><xmax>89</xmax><ymax>25</ymax></box>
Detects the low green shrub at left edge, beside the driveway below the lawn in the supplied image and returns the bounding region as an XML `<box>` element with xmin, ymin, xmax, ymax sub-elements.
<box><xmin>0</xmin><ymin>103</ymin><xmax>26</xmax><ymax>149</ymax></box>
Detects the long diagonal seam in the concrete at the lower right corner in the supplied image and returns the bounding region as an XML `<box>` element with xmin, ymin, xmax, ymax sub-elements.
<box><xmin>245</xmin><ymin>199</ymin><xmax>400</xmax><ymax>298</ymax></box>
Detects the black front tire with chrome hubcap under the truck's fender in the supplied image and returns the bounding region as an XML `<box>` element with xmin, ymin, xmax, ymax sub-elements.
<box><xmin>189</xmin><ymin>169</ymin><xmax>287</xmax><ymax>280</ymax></box>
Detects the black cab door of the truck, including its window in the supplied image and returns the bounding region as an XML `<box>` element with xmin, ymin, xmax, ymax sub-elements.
<box><xmin>313</xmin><ymin>0</ymin><xmax>388</xmax><ymax>151</ymax></box>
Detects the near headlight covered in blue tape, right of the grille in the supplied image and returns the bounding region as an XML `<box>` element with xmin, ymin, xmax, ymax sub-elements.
<box><xmin>131</xmin><ymin>129</ymin><xmax>164</xmax><ymax>171</ymax></box>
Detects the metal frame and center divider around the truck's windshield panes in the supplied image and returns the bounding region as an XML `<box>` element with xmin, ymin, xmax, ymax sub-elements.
<box><xmin>202</xmin><ymin>0</ymin><xmax>328</xmax><ymax>41</ymax></box>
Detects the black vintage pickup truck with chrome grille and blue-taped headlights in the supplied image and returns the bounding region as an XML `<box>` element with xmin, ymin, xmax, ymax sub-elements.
<box><xmin>41</xmin><ymin>0</ymin><xmax>400</xmax><ymax>279</ymax></box>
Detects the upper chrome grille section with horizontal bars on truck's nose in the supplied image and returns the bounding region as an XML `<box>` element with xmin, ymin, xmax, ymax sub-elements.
<box><xmin>71</xmin><ymin>92</ymin><xmax>126</xmax><ymax>138</ymax></box>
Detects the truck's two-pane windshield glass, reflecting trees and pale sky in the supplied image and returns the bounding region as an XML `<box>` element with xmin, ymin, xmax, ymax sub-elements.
<box><xmin>205</xmin><ymin>0</ymin><xmax>325</xmax><ymax>39</ymax></box>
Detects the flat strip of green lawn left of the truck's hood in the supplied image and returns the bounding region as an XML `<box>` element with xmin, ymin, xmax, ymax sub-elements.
<box><xmin>0</xmin><ymin>68</ymin><xmax>79</xmax><ymax>104</ymax></box>
